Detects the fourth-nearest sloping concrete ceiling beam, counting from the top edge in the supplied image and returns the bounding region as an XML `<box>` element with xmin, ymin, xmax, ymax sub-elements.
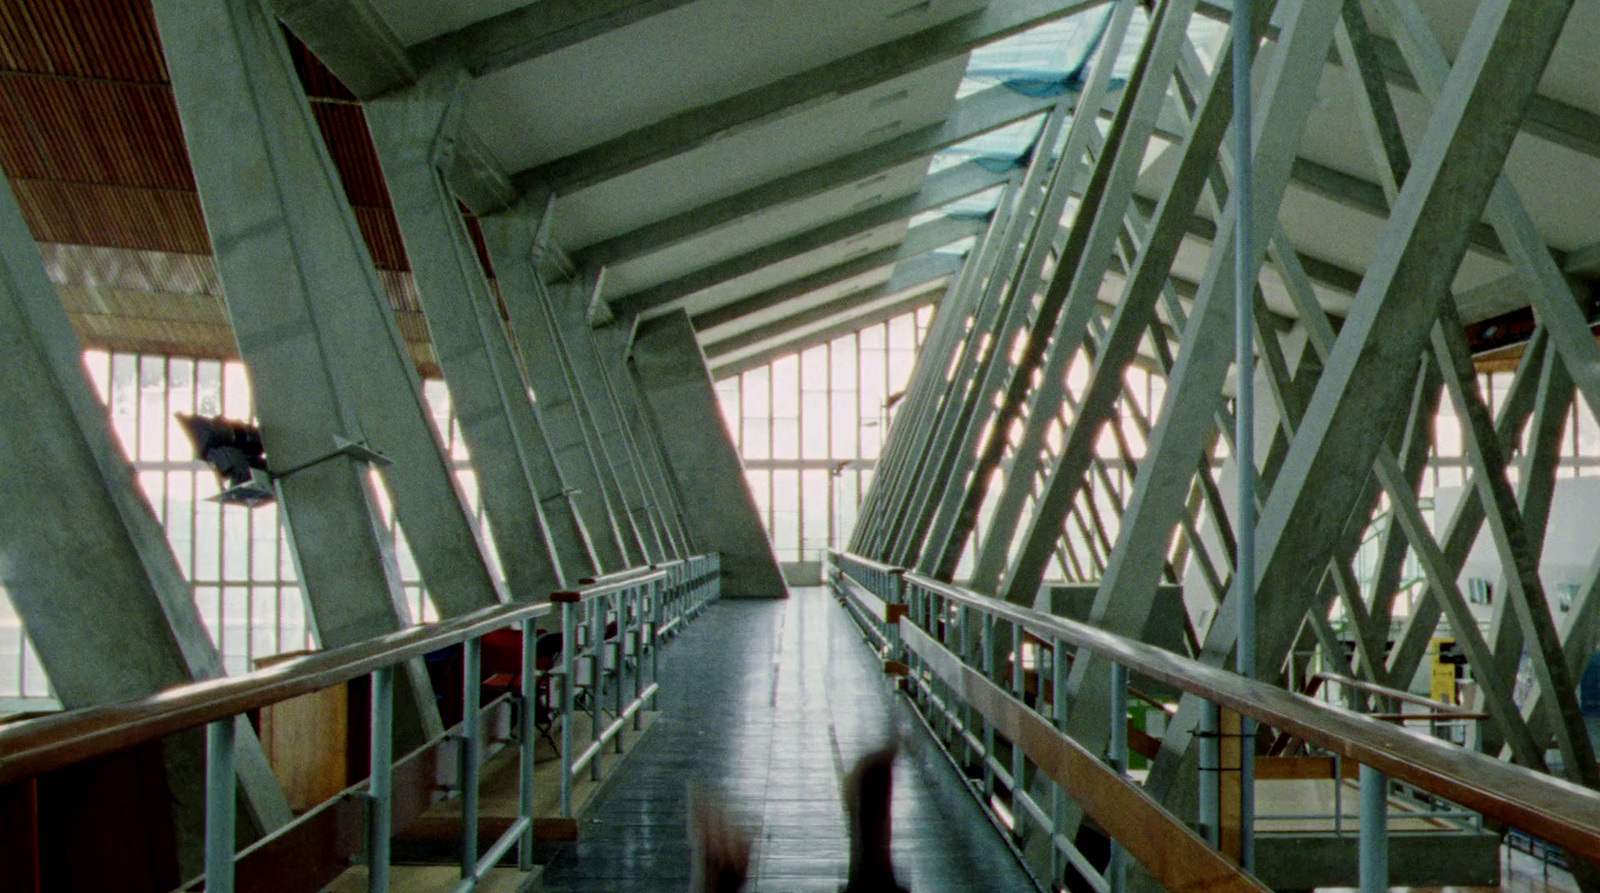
<box><xmin>611</xmin><ymin>162</ymin><xmax>1010</xmax><ymax>317</ymax></box>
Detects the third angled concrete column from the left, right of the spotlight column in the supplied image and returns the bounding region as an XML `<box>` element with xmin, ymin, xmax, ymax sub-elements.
<box><xmin>366</xmin><ymin>75</ymin><xmax>594</xmax><ymax>600</ymax></box>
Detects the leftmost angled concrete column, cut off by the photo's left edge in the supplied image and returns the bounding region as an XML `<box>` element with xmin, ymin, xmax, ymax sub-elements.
<box><xmin>0</xmin><ymin>171</ymin><xmax>290</xmax><ymax>871</ymax></box>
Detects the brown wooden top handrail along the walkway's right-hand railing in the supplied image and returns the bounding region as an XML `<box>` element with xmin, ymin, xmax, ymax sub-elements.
<box><xmin>906</xmin><ymin>573</ymin><xmax>1600</xmax><ymax>859</ymax></box>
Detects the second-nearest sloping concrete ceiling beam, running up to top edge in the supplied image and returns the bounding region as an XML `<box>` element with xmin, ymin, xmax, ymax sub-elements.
<box><xmin>514</xmin><ymin>0</ymin><xmax>1104</xmax><ymax>195</ymax></box>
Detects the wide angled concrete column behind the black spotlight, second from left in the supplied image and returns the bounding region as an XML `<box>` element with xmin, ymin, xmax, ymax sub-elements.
<box><xmin>155</xmin><ymin>0</ymin><xmax>501</xmax><ymax>743</ymax></box>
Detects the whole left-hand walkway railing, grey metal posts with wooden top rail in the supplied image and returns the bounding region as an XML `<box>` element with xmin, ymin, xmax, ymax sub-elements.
<box><xmin>0</xmin><ymin>554</ymin><xmax>720</xmax><ymax>893</ymax></box>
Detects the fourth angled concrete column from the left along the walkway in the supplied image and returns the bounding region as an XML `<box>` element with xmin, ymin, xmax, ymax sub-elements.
<box><xmin>478</xmin><ymin>205</ymin><xmax>630</xmax><ymax>573</ymax></box>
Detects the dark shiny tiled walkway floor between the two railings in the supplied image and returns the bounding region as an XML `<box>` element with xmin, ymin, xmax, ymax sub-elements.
<box><xmin>542</xmin><ymin>587</ymin><xmax>1034</xmax><ymax>893</ymax></box>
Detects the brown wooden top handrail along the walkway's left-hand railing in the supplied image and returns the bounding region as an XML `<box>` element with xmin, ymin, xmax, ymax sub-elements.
<box><xmin>0</xmin><ymin>568</ymin><xmax>700</xmax><ymax>786</ymax></box>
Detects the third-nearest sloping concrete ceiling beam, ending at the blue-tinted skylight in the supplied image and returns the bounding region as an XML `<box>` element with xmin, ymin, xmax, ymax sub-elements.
<box><xmin>573</xmin><ymin>86</ymin><xmax>1058</xmax><ymax>269</ymax></box>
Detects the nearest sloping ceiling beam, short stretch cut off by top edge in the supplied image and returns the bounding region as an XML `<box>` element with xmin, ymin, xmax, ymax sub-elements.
<box><xmin>410</xmin><ymin>0</ymin><xmax>693</xmax><ymax>77</ymax></box>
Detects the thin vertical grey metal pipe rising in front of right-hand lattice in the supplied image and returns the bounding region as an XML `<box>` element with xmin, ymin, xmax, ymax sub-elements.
<box><xmin>1234</xmin><ymin>0</ymin><xmax>1256</xmax><ymax>871</ymax></box>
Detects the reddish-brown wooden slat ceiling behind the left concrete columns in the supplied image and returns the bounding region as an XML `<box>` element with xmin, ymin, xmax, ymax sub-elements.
<box><xmin>0</xmin><ymin>0</ymin><xmax>422</xmax><ymax>270</ymax></box>
